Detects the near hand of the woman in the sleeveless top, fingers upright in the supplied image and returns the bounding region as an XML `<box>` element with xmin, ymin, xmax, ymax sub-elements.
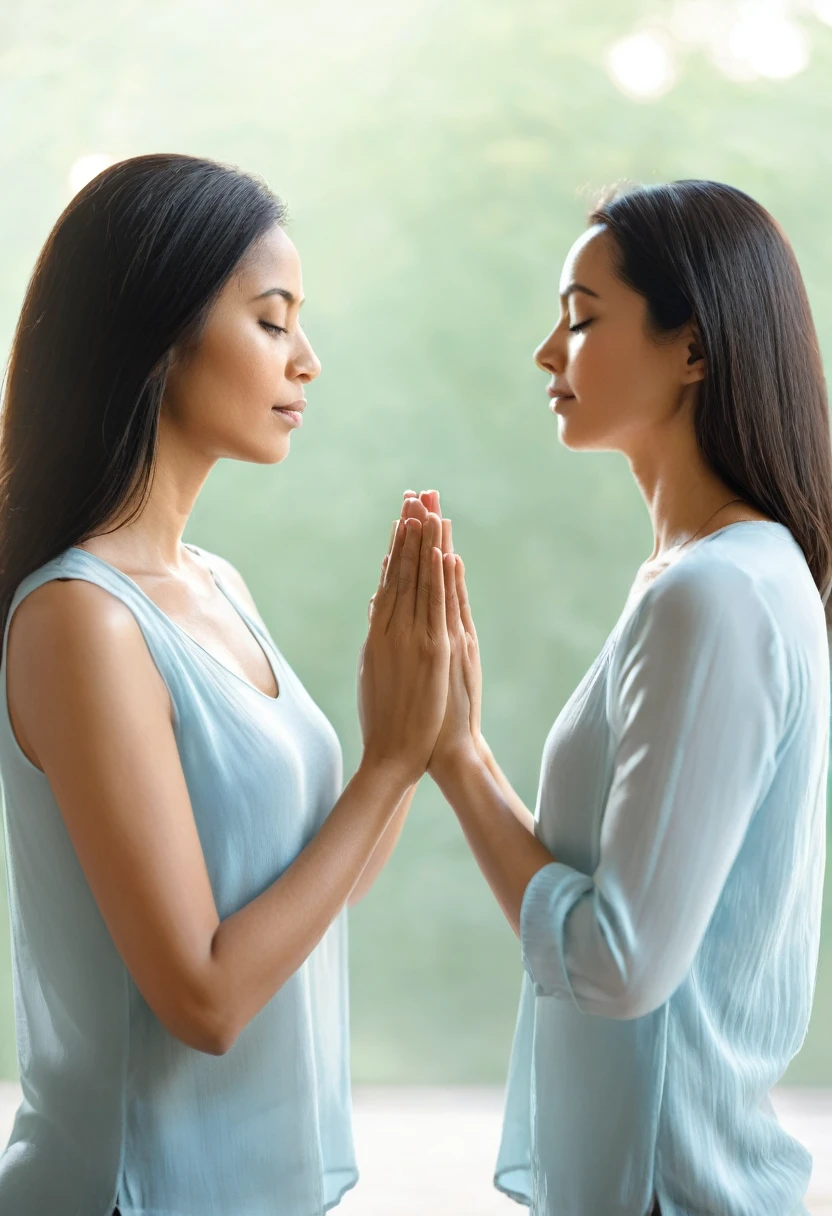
<box><xmin>359</xmin><ymin>512</ymin><xmax>450</xmax><ymax>784</ymax></box>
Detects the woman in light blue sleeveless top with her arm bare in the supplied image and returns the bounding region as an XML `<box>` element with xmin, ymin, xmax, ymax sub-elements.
<box><xmin>0</xmin><ymin>156</ymin><xmax>454</xmax><ymax>1216</ymax></box>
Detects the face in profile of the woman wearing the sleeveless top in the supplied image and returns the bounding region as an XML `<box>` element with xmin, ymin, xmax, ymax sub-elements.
<box><xmin>162</xmin><ymin>218</ymin><xmax>321</xmax><ymax>465</ymax></box>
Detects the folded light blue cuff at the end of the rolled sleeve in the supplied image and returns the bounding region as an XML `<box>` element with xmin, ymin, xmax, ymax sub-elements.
<box><xmin>521</xmin><ymin>861</ymin><xmax>594</xmax><ymax>1009</ymax></box>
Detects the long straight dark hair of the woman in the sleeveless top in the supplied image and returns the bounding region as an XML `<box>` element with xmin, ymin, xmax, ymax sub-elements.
<box><xmin>0</xmin><ymin>153</ymin><xmax>286</xmax><ymax>636</ymax></box>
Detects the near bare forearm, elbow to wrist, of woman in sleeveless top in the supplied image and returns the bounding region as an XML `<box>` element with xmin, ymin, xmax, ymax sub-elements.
<box><xmin>207</xmin><ymin>762</ymin><xmax>409</xmax><ymax>1049</ymax></box>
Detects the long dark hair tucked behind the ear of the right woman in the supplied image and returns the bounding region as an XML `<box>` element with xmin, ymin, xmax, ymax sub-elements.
<box><xmin>589</xmin><ymin>180</ymin><xmax>832</xmax><ymax>630</ymax></box>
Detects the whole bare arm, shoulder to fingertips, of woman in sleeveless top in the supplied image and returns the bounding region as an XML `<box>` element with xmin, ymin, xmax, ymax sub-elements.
<box><xmin>7</xmin><ymin>522</ymin><xmax>448</xmax><ymax>1054</ymax></box>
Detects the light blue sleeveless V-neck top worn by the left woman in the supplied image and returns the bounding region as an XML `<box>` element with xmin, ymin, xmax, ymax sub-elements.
<box><xmin>0</xmin><ymin>545</ymin><xmax>358</xmax><ymax>1216</ymax></box>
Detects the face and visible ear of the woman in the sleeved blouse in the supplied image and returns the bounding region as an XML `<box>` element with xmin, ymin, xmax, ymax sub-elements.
<box><xmin>534</xmin><ymin>224</ymin><xmax>703</xmax><ymax>454</ymax></box>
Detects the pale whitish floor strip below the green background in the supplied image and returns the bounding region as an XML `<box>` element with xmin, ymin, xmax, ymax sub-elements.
<box><xmin>0</xmin><ymin>1081</ymin><xmax>832</xmax><ymax>1216</ymax></box>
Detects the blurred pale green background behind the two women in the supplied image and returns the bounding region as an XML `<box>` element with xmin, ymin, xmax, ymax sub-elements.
<box><xmin>0</xmin><ymin>0</ymin><xmax>832</xmax><ymax>1085</ymax></box>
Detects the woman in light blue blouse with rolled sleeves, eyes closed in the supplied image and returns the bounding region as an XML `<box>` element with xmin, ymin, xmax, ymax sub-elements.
<box><xmin>418</xmin><ymin>181</ymin><xmax>832</xmax><ymax>1216</ymax></box>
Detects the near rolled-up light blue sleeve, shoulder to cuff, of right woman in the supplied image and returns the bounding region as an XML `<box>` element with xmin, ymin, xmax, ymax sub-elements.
<box><xmin>521</xmin><ymin>561</ymin><xmax>788</xmax><ymax>1018</ymax></box>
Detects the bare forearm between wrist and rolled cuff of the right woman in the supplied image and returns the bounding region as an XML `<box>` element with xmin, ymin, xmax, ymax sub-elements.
<box><xmin>431</xmin><ymin>747</ymin><xmax>556</xmax><ymax>936</ymax></box>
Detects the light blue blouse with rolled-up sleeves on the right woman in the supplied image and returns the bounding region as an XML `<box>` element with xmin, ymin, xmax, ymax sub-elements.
<box><xmin>495</xmin><ymin>520</ymin><xmax>830</xmax><ymax>1216</ymax></box>
